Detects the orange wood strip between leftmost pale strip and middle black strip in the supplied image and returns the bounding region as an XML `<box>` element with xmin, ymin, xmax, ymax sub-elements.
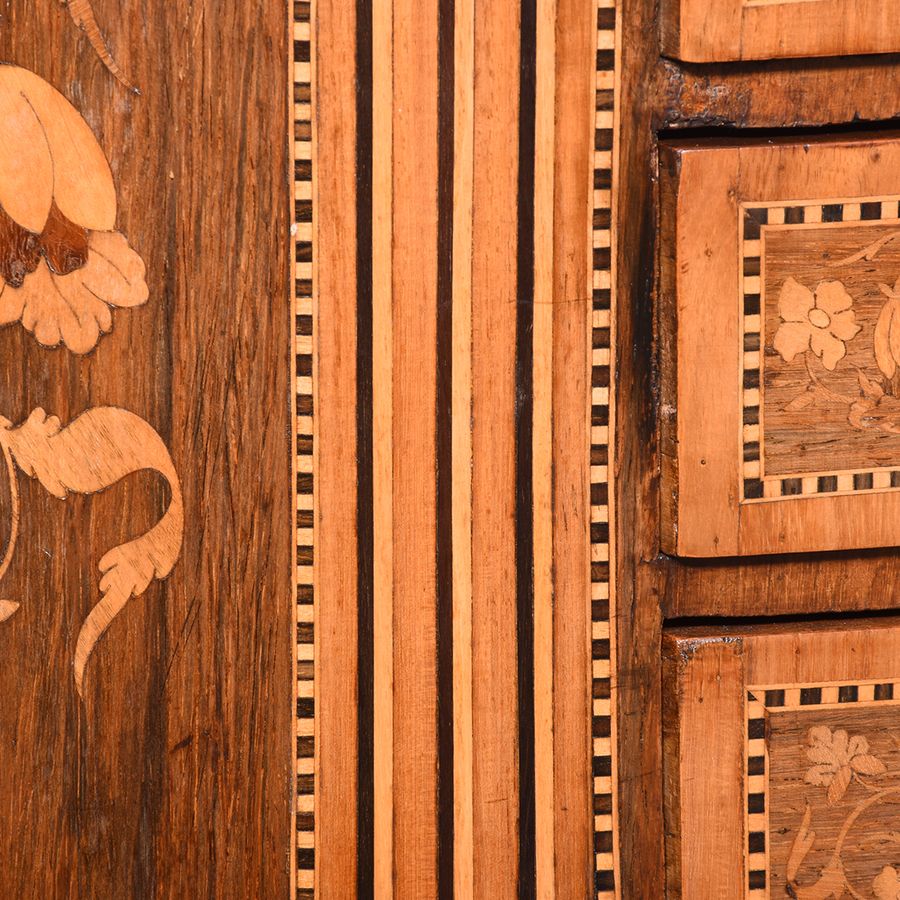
<box><xmin>392</xmin><ymin>0</ymin><xmax>438</xmax><ymax>900</ymax></box>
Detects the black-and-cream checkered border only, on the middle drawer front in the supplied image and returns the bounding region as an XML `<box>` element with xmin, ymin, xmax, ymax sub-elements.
<box><xmin>741</xmin><ymin>198</ymin><xmax>900</xmax><ymax>503</ymax></box>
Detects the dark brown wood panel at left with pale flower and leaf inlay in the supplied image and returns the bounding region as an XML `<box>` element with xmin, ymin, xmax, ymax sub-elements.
<box><xmin>0</xmin><ymin>2</ymin><xmax>294</xmax><ymax>898</ymax></box>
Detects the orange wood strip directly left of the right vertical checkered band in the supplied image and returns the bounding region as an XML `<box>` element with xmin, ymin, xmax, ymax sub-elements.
<box><xmin>548</xmin><ymin>0</ymin><xmax>596</xmax><ymax>897</ymax></box>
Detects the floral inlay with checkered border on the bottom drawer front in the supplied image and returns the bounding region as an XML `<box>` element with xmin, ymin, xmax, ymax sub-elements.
<box><xmin>745</xmin><ymin>680</ymin><xmax>900</xmax><ymax>900</ymax></box>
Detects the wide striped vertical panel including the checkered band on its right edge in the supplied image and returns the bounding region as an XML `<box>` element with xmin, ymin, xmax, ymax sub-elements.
<box><xmin>308</xmin><ymin>0</ymin><xmax>616</xmax><ymax>898</ymax></box>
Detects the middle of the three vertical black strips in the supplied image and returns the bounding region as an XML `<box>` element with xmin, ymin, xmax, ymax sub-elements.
<box><xmin>435</xmin><ymin>0</ymin><xmax>456</xmax><ymax>900</ymax></box>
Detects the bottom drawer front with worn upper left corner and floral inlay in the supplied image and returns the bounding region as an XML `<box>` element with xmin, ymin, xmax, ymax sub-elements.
<box><xmin>665</xmin><ymin>620</ymin><xmax>900</xmax><ymax>900</ymax></box>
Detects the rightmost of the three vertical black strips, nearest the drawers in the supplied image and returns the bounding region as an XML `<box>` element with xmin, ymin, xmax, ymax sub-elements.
<box><xmin>515</xmin><ymin>0</ymin><xmax>537</xmax><ymax>900</ymax></box>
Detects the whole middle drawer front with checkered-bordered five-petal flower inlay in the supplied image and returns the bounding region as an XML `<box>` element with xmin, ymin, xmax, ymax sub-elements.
<box><xmin>660</xmin><ymin>137</ymin><xmax>900</xmax><ymax>556</ymax></box>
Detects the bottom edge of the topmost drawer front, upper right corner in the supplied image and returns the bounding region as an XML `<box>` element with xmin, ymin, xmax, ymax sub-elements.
<box><xmin>661</xmin><ymin>0</ymin><xmax>900</xmax><ymax>62</ymax></box>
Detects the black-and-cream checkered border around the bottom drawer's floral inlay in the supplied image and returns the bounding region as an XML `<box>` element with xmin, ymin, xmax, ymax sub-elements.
<box><xmin>744</xmin><ymin>681</ymin><xmax>900</xmax><ymax>900</ymax></box>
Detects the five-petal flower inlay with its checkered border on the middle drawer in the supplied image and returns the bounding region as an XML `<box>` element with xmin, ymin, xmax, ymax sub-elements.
<box><xmin>742</xmin><ymin>197</ymin><xmax>900</xmax><ymax>502</ymax></box>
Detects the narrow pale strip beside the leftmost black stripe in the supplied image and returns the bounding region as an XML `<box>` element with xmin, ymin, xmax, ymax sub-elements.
<box><xmin>372</xmin><ymin>0</ymin><xmax>394</xmax><ymax>898</ymax></box>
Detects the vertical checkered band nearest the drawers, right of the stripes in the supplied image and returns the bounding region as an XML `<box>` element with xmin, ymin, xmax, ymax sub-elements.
<box><xmin>591</xmin><ymin>0</ymin><xmax>616</xmax><ymax>900</ymax></box>
